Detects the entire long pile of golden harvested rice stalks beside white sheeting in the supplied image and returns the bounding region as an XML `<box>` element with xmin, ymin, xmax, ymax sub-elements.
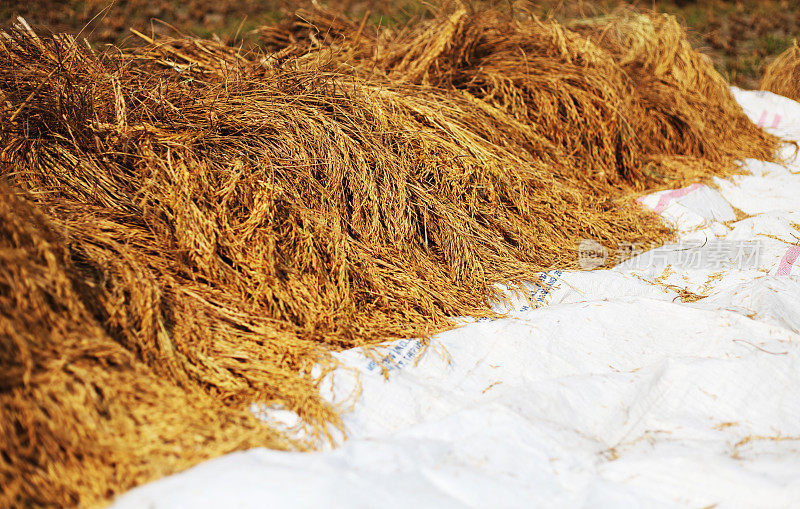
<box><xmin>0</xmin><ymin>9</ymin><xmax>777</xmax><ymax>505</ymax></box>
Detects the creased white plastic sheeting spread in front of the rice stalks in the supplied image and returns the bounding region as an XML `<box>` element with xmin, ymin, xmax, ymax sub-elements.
<box><xmin>115</xmin><ymin>89</ymin><xmax>800</xmax><ymax>508</ymax></box>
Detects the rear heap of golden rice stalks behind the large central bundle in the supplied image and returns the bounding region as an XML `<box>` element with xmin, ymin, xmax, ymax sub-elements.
<box><xmin>262</xmin><ymin>7</ymin><xmax>776</xmax><ymax>190</ymax></box>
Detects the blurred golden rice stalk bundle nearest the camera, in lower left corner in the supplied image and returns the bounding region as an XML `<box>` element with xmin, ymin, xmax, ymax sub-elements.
<box><xmin>0</xmin><ymin>185</ymin><xmax>301</xmax><ymax>507</ymax></box>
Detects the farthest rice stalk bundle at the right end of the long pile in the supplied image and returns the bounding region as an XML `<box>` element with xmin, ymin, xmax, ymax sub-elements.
<box><xmin>579</xmin><ymin>14</ymin><xmax>776</xmax><ymax>179</ymax></box>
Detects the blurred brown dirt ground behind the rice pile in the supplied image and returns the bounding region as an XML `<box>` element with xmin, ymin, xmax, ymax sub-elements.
<box><xmin>6</xmin><ymin>0</ymin><xmax>800</xmax><ymax>88</ymax></box>
